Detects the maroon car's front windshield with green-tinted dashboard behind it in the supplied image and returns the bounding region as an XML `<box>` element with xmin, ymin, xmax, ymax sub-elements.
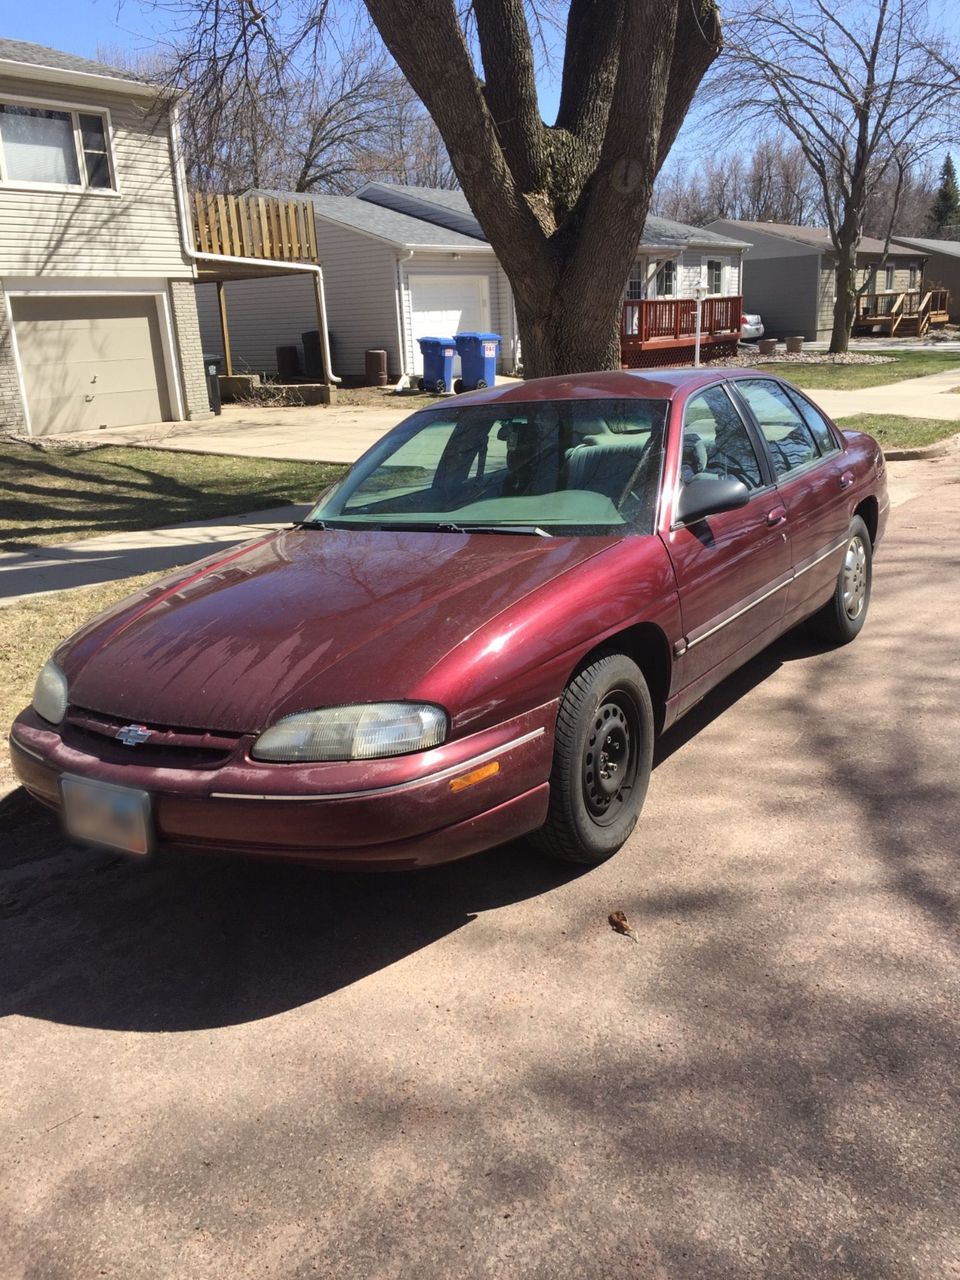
<box><xmin>307</xmin><ymin>399</ymin><xmax>667</xmax><ymax>535</ymax></box>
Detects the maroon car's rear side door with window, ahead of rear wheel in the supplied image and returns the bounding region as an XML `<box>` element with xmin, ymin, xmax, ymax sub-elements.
<box><xmin>732</xmin><ymin>378</ymin><xmax>852</xmax><ymax>613</ymax></box>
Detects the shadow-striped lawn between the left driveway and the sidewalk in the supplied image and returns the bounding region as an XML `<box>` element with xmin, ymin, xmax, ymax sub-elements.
<box><xmin>0</xmin><ymin>443</ymin><xmax>346</xmax><ymax>550</ymax></box>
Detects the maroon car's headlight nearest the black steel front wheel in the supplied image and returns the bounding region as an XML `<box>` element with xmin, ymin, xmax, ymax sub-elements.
<box><xmin>251</xmin><ymin>703</ymin><xmax>447</xmax><ymax>763</ymax></box>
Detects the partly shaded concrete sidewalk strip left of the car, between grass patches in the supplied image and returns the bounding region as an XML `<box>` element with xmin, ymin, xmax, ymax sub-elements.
<box><xmin>0</xmin><ymin>503</ymin><xmax>310</xmax><ymax>607</ymax></box>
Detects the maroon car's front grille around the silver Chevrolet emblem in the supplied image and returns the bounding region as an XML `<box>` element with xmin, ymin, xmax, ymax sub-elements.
<box><xmin>60</xmin><ymin>707</ymin><xmax>242</xmax><ymax>769</ymax></box>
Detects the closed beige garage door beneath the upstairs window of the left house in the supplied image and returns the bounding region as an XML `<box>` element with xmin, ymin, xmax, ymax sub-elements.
<box><xmin>13</xmin><ymin>296</ymin><xmax>170</xmax><ymax>435</ymax></box>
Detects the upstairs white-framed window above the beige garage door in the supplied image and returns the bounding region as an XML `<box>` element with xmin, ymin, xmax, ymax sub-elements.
<box><xmin>0</xmin><ymin>102</ymin><xmax>114</xmax><ymax>189</ymax></box>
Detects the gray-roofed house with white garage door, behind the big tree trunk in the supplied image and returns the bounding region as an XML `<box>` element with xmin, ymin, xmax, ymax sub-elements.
<box><xmin>197</xmin><ymin>183</ymin><xmax>746</xmax><ymax>380</ymax></box>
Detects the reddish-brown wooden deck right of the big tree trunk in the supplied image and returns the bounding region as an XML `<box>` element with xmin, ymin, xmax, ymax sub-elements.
<box><xmin>620</xmin><ymin>296</ymin><xmax>744</xmax><ymax>369</ymax></box>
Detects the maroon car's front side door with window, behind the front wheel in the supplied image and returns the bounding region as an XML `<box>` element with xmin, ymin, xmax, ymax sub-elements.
<box><xmin>662</xmin><ymin>383</ymin><xmax>791</xmax><ymax>709</ymax></box>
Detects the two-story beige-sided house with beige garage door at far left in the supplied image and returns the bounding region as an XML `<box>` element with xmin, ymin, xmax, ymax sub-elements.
<box><xmin>0</xmin><ymin>40</ymin><xmax>210</xmax><ymax>435</ymax></box>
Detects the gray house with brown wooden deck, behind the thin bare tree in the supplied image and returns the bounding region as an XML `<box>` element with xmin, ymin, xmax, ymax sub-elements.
<box><xmin>708</xmin><ymin>219</ymin><xmax>925</xmax><ymax>340</ymax></box>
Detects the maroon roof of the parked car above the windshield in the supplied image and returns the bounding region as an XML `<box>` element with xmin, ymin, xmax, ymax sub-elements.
<box><xmin>457</xmin><ymin>365</ymin><xmax>771</xmax><ymax>404</ymax></box>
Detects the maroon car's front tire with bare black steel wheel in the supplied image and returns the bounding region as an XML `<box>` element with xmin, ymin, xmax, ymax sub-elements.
<box><xmin>531</xmin><ymin>653</ymin><xmax>654</xmax><ymax>865</ymax></box>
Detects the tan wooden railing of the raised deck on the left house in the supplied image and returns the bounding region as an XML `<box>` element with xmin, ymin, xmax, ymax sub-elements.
<box><xmin>191</xmin><ymin>192</ymin><xmax>319</xmax><ymax>262</ymax></box>
